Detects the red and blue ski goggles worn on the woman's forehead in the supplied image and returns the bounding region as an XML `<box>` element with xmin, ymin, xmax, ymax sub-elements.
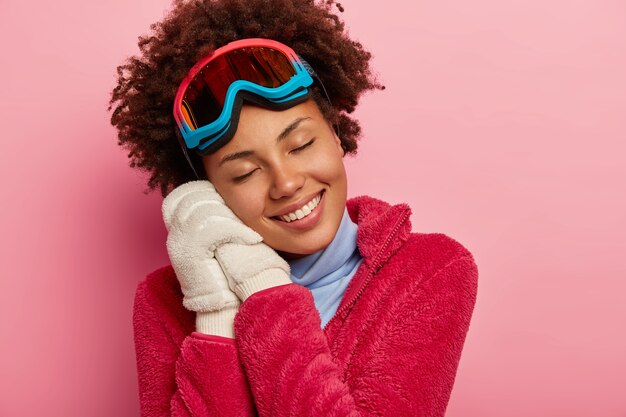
<box><xmin>174</xmin><ymin>38</ymin><xmax>316</xmax><ymax>156</ymax></box>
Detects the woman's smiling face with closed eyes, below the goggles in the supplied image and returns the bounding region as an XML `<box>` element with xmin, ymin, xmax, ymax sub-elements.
<box><xmin>203</xmin><ymin>99</ymin><xmax>347</xmax><ymax>259</ymax></box>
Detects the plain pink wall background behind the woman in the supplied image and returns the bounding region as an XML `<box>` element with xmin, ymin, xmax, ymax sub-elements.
<box><xmin>0</xmin><ymin>0</ymin><xmax>626</xmax><ymax>417</ymax></box>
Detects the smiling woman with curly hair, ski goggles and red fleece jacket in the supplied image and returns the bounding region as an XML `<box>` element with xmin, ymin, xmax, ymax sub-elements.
<box><xmin>111</xmin><ymin>0</ymin><xmax>477</xmax><ymax>416</ymax></box>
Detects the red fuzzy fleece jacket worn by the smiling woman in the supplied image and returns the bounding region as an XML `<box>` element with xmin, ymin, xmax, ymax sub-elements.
<box><xmin>133</xmin><ymin>197</ymin><xmax>478</xmax><ymax>417</ymax></box>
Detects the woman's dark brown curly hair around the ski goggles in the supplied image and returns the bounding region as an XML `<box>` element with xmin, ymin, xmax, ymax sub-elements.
<box><xmin>108</xmin><ymin>0</ymin><xmax>385</xmax><ymax>197</ymax></box>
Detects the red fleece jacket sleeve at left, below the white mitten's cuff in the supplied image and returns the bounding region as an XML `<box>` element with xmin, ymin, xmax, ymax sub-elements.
<box><xmin>133</xmin><ymin>276</ymin><xmax>256</xmax><ymax>417</ymax></box>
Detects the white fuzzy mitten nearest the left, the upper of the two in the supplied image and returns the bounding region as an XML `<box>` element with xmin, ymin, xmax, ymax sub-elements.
<box><xmin>162</xmin><ymin>181</ymin><xmax>262</xmax><ymax>337</ymax></box>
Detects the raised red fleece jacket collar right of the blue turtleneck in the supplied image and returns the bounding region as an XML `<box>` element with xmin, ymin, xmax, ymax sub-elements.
<box><xmin>346</xmin><ymin>196</ymin><xmax>411</xmax><ymax>272</ymax></box>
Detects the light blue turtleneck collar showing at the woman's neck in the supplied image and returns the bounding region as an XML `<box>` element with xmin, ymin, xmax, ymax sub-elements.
<box><xmin>288</xmin><ymin>209</ymin><xmax>363</xmax><ymax>327</ymax></box>
